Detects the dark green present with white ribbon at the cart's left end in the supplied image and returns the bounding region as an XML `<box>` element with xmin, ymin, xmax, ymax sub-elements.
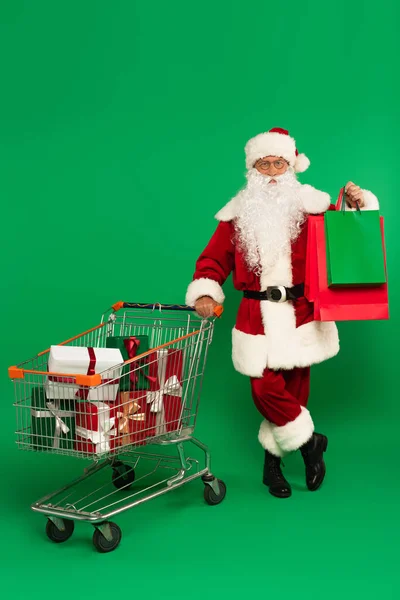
<box><xmin>31</xmin><ymin>386</ymin><xmax>75</xmax><ymax>450</ymax></box>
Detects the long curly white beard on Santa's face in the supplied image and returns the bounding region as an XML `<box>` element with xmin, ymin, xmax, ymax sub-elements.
<box><xmin>236</xmin><ymin>169</ymin><xmax>304</xmax><ymax>275</ymax></box>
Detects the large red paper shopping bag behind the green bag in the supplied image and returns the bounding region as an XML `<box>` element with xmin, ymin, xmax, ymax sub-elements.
<box><xmin>308</xmin><ymin>217</ymin><xmax>389</xmax><ymax>321</ymax></box>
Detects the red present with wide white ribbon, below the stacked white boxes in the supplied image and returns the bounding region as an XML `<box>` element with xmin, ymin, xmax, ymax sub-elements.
<box><xmin>75</xmin><ymin>402</ymin><xmax>116</xmax><ymax>455</ymax></box>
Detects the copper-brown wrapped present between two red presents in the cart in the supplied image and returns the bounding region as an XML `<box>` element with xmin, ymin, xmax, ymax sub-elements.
<box><xmin>114</xmin><ymin>390</ymin><xmax>156</xmax><ymax>447</ymax></box>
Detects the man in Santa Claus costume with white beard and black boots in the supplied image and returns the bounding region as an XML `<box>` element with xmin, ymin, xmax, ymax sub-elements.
<box><xmin>186</xmin><ymin>128</ymin><xmax>378</xmax><ymax>498</ymax></box>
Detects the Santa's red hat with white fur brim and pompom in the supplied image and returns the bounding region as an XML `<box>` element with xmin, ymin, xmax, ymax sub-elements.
<box><xmin>245</xmin><ymin>127</ymin><xmax>310</xmax><ymax>173</ymax></box>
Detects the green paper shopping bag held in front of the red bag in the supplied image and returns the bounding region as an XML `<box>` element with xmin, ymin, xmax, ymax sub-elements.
<box><xmin>325</xmin><ymin>188</ymin><xmax>386</xmax><ymax>287</ymax></box>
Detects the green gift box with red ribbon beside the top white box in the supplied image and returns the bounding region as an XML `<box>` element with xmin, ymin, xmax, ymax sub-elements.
<box><xmin>106</xmin><ymin>335</ymin><xmax>150</xmax><ymax>391</ymax></box>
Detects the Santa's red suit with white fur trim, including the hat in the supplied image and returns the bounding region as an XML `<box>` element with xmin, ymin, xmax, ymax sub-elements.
<box><xmin>186</xmin><ymin>125</ymin><xmax>378</xmax><ymax>456</ymax></box>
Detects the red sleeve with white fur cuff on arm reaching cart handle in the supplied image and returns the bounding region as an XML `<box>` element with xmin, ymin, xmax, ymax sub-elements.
<box><xmin>186</xmin><ymin>221</ymin><xmax>234</xmax><ymax>306</ymax></box>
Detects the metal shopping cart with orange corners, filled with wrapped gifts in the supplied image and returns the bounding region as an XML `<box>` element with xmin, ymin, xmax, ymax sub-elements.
<box><xmin>9</xmin><ymin>302</ymin><xmax>226</xmax><ymax>552</ymax></box>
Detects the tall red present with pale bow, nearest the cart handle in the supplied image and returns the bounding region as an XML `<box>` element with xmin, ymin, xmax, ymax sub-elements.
<box><xmin>147</xmin><ymin>348</ymin><xmax>183</xmax><ymax>435</ymax></box>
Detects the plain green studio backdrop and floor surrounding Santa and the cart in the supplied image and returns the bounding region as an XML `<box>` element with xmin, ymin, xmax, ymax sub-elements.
<box><xmin>0</xmin><ymin>0</ymin><xmax>400</xmax><ymax>598</ymax></box>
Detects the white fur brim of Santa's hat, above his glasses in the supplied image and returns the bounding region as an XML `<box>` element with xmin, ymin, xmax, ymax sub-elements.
<box><xmin>245</xmin><ymin>132</ymin><xmax>296</xmax><ymax>169</ymax></box>
